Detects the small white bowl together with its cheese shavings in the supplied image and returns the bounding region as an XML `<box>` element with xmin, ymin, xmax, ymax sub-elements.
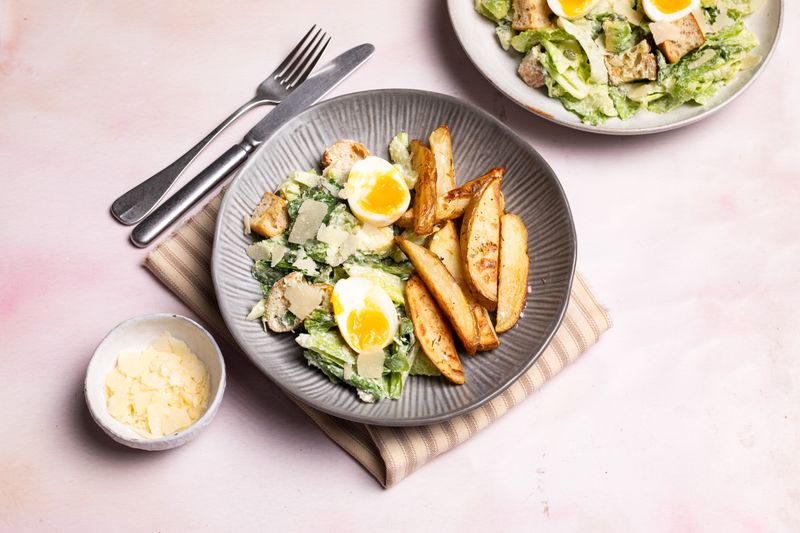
<box><xmin>84</xmin><ymin>313</ymin><xmax>226</xmax><ymax>451</ymax></box>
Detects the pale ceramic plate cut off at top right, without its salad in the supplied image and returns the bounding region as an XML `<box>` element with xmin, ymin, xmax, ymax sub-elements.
<box><xmin>447</xmin><ymin>0</ymin><xmax>783</xmax><ymax>135</ymax></box>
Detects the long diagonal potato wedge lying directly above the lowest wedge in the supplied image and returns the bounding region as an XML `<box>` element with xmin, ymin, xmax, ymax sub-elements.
<box><xmin>395</xmin><ymin>236</ymin><xmax>478</xmax><ymax>355</ymax></box>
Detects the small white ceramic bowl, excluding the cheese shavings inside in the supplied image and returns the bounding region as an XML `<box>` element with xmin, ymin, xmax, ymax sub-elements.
<box><xmin>84</xmin><ymin>313</ymin><xmax>225</xmax><ymax>451</ymax></box>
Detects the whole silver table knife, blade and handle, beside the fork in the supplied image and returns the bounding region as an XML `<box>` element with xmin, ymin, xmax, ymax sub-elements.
<box><xmin>131</xmin><ymin>44</ymin><xmax>375</xmax><ymax>248</ymax></box>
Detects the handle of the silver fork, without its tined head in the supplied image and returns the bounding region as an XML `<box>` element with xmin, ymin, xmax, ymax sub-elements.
<box><xmin>111</xmin><ymin>97</ymin><xmax>268</xmax><ymax>225</ymax></box>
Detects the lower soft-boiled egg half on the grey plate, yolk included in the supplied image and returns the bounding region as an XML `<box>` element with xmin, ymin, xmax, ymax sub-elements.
<box><xmin>331</xmin><ymin>277</ymin><xmax>399</xmax><ymax>354</ymax></box>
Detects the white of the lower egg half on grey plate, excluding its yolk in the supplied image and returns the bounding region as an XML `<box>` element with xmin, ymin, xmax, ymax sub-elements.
<box><xmin>331</xmin><ymin>277</ymin><xmax>400</xmax><ymax>353</ymax></box>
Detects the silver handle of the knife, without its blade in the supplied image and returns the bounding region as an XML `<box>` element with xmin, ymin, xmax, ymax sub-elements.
<box><xmin>131</xmin><ymin>143</ymin><xmax>253</xmax><ymax>248</ymax></box>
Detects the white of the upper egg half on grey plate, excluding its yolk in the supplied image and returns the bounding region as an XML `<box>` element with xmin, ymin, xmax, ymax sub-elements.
<box><xmin>345</xmin><ymin>156</ymin><xmax>411</xmax><ymax>227</ymax></box>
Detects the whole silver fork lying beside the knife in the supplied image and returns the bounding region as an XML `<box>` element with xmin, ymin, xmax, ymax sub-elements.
<box><xmin>111</xmin><ymin>25</ymin><xmax>331</xmax><ymax>225</ymax></box>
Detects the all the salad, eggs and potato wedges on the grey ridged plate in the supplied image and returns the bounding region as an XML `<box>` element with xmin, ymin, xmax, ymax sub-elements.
<box><xmin>244</xmin><ymin>125</ymin><xmax>529</xmax><ymax>402</ymax></box>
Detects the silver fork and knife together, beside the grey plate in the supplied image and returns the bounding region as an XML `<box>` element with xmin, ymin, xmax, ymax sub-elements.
<box><xmin>111</xmin><ymin>27</ymin><xmax>375</xmax><ymax>247</ymax></box>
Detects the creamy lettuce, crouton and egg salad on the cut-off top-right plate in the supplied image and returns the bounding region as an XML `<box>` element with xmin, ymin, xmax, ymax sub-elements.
<box><xmin>475</xmin><ymin>0</ymin><xmax>762</xmax><ymax>125</ymax></box>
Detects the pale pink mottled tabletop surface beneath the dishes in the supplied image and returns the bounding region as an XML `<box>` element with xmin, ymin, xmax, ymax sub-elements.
<box><xmin>0</xmin><ymin>0</ymin><xmax>800</xmax><ymax>532</ymax></box>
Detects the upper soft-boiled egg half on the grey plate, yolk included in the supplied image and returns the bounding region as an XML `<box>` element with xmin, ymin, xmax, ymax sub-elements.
<box><xmin>344</xmin><ymin>156</ymin><xmax>411</xmax><ymax>228</ymax></box>
